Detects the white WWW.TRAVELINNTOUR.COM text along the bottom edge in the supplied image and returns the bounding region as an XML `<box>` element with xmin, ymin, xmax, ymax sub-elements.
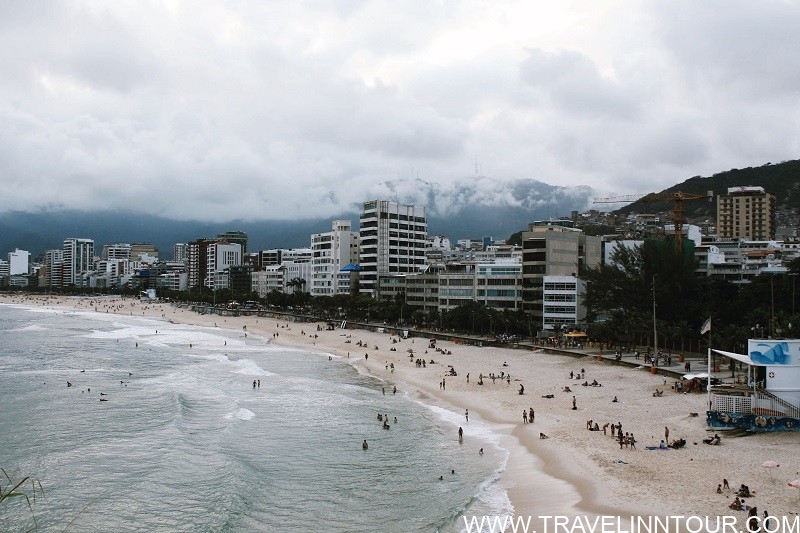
<box><xmin>462</xmin><ymin>515</ymin><xmax>800</xmax><ymax>533</ymax></box>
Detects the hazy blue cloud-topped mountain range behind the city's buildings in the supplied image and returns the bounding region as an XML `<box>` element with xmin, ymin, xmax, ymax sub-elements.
<box><xmin>0</xmin><ymin>177</ymin><xmax>597</xmax><ymax>259</ymax></box>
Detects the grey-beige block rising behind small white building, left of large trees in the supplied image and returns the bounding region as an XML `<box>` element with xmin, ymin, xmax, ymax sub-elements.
<box><xmin>522</xmin><ymin>224</ymin><xmax>602</xmax><ymax>326</ymax></box>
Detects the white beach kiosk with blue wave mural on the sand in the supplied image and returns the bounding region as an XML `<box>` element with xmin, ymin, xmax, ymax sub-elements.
<box><xmin>706</xmin><ymin>339</ymin><xmax>800</xmax><ymax>431</ymax></box>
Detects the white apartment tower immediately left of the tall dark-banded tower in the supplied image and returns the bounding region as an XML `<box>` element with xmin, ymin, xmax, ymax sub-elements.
<box><xmin>309</xmin><ymin>220</ymin><xmax>358</xmax><ymax>296</ymax></box>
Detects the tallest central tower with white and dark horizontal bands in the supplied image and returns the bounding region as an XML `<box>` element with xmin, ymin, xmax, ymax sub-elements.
<box><xmin>359</xmin><ymin>200</ymin><xmax>428</xmax><ymax>297</ymax></box>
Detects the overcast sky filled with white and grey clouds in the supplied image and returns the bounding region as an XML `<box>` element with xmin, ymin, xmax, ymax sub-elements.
<box><xmin>0</xmin><ymin>0</ymin><xmax>800</xmax><ymax>221</ymax></box>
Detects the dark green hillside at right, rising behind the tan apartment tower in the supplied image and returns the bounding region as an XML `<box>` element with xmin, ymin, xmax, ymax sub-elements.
<box><xmin>614</xmin><ymin>160</ymin><xmax>800</xmax><ymax>220</ymax></box>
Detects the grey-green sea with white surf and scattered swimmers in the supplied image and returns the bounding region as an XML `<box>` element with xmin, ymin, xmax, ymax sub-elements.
<box><xmin>0</xmin><ymin>305</ymin><xmax>511</xmax><ymax>532</ymax></box>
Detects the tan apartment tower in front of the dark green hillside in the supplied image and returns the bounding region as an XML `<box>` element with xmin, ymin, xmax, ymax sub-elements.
<box><xmin>717</xmin><ymin>186</ymin><xmax>776</xmax><ymax>241</ymax></box>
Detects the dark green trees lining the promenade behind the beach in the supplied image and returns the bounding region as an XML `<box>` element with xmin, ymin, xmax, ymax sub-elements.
<box><xmin>5</xmin><ymin>243</ymin><xmax>800</xmax><ymax>353</ymax></box>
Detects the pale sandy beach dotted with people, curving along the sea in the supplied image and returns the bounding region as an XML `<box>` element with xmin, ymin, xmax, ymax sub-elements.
<box><xmin>6</xmin><ymin>295</ymin><xmax>800</xmax><ymax>523</ymax></box>
